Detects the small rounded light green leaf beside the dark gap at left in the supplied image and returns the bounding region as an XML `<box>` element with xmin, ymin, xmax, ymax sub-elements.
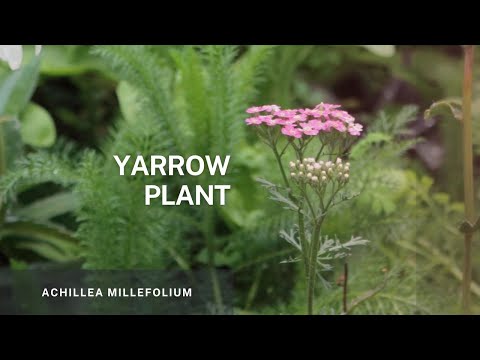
<box><xmin>20</xmin><ymin>103</ymin><xmax>57</xmax><ymax>147</ymax></box>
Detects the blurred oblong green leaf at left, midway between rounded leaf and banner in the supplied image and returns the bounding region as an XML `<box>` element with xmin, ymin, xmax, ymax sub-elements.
<box><xmin>16</xmin><ymin>192</ymin><xmax>77</xmax><ymax>221</ymax></box>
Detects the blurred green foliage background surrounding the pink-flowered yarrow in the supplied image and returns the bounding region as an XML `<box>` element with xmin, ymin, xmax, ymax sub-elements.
<box><xmin>0</xmin><ymin>45</ymin><xmax>474</xmax><ymax>314</ymax></box>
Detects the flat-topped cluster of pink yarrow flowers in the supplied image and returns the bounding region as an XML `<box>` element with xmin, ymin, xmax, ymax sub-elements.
<box><xmin>245</xmin><ymin>103</ymin><xmax>363</xmax><ymax>139</ymax></box>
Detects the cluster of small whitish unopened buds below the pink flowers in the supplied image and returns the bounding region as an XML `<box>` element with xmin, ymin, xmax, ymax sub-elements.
<box><xmin>289</xmin><ymin>158</ymin><xmax>350</xmax><ymax>186</ymax></box>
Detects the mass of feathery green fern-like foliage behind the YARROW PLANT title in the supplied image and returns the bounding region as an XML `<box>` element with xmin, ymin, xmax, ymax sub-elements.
<box><xmin>0</xmin><ymin>46</ymin><xmax>272</xmax><ymax>269</ymax></box>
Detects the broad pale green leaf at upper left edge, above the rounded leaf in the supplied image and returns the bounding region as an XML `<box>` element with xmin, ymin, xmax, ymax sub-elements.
<box><xmin>0</xmin><ymin>57</ymin><xmax>40</xmax><ymax>116</ymax></box>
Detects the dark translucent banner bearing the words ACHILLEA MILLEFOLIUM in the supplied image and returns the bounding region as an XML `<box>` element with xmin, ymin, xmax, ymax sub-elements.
<box><xmin>0</xmin><ymin>270</ymin><xmax>232</xmax><ymax>315</ymax></box>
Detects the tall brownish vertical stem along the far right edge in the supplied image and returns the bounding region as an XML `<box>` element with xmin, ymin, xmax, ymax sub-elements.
<box><xmin>462</xmin><ymin>45</ymin><xmax>475</xmax><ymax>314</ymax></box>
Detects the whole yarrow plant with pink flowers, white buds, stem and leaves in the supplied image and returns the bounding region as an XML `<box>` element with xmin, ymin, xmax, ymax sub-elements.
<box><xmin>245</xmin><ymin>103</ymin><xmax>367</xmax><ymax>314</ymax></box>
